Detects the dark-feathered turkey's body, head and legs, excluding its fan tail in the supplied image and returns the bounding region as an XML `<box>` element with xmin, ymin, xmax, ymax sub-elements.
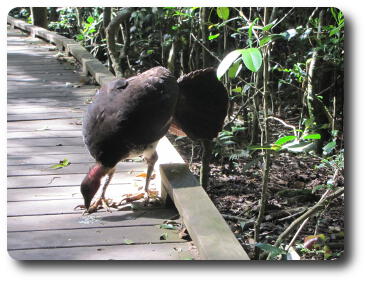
<box><xmin>81</xmin><ymin>67</ymin><xmax>179</xmax><ymax>213</ymax></box>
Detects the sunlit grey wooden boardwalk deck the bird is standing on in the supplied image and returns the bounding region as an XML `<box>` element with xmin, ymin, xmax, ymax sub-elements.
<box><xmin>7</xmin><ymin>28</ymin><xmax>197</xmax><ymax>260</ymax></box>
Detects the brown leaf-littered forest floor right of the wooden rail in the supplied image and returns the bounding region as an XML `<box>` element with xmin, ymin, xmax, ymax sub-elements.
<box><xmin>168</xmin><ymin>120</ymin><xmax>344</xmax><ymax>260</ymax></box>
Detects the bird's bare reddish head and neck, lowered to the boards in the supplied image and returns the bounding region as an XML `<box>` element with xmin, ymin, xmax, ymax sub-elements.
<box><xmin>80</xmin><ymin>164</ymin><xmax>107</xmax><ymax>210</ymax></box>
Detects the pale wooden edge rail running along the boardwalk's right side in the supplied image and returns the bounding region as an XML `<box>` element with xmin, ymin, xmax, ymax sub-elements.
<box><xmin>8</xmin><ymin>16</ymin><xmax>249</xmax><ymax>260</ymax></box>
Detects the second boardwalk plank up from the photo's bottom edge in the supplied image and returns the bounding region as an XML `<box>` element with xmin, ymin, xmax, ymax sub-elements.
<box><xmin>8</xmin><ymin>225</ymin><xmax>185</xmax><ymax>250</ymax></box>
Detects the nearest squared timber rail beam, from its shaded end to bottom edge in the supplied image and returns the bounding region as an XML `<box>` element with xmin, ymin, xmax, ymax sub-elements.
<box><xmin>160</xmin><ymin>164</ymin><xmax>249</xmax><ymax>260</ymax></box>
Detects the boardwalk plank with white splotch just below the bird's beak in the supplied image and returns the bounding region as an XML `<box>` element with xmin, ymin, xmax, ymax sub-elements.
<box><xmin>8</xmin><ymin>208</ymin><xmax>177</xmax><ymax>232</ymax></box>
